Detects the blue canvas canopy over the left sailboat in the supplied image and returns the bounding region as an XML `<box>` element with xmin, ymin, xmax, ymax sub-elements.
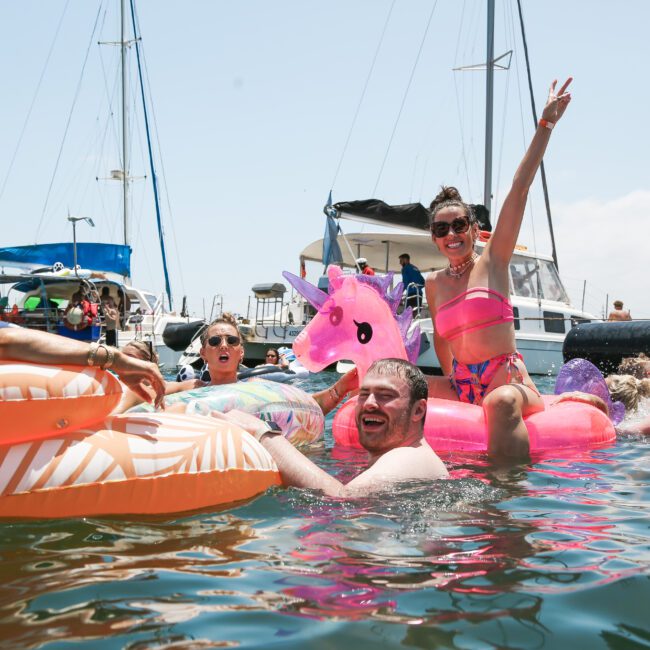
<box><xmin>0</xmin><ymin>242</ymin><xmax>131</xmax><ymax>277</ymax></box>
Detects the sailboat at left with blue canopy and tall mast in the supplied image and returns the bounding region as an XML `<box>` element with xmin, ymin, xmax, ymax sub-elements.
<box><xmin>0</xmin><ymin>0</ymin><xmax>203</xmax><ymax>369</ymax></box>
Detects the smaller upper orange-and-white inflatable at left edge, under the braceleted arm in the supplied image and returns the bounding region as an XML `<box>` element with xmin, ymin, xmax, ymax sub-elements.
<box><xmin>0</xmin><ymin>361</ymin><xmax>122</xmax><ymax>444</ymax></box>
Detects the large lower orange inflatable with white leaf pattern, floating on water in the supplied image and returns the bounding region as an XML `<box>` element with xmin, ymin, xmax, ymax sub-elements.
<box><xmin>0</xmin><ymin>413</ymin><xmax>281</xmax><ymax>519</ymax></box>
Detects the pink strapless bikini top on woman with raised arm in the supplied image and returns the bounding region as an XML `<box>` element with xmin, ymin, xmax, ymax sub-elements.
<box><xmin>435</xmin><ymin>287</ymin><xmax>515</xmax><ymax>341</ymax></box>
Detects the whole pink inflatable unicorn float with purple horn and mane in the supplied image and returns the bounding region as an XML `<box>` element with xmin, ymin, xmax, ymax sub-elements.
<box><xmin>283</xmin><ymin>265</ymin><xmax>616</xmax><ymax>453</ymax></box>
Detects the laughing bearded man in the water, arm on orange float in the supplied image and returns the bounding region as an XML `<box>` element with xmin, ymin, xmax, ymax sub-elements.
<box><xmin>213</xmin><ymin>359</ymin><xmax>448</xmax><ymax>497</ymax></box>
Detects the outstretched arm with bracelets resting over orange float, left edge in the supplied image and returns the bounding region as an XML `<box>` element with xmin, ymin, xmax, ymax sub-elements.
<box><xmin>0</xmin><ymin>323</ymin><xmax>165</xmax><ymax>406</ymax></box>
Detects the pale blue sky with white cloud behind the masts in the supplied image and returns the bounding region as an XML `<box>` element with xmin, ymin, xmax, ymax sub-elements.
<box><xmin>0</xmin><ymin>0</ymin><xmax>650</xmax><ymax>318</ymax></box>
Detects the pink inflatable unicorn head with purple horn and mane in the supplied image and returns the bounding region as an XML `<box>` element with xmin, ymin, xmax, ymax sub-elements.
<box><xmin>282</xmin><ymin>265</ymin><xmax>420</xmax><ymax>380</ymax></box>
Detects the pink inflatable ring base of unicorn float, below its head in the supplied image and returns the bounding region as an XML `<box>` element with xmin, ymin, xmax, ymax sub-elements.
<box><xmin>332</xmin><ymin>395</ymin><xmax>616</xmax><ymax>453</ymax></box>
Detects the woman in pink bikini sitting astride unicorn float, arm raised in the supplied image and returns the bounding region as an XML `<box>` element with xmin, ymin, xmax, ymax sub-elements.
<box><xmin>425</xmin><ymin>78</ymin><xmax>572</xmax><ymax>456</ymax></box>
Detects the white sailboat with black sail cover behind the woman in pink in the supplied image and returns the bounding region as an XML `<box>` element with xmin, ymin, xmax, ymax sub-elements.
<box><xmin>300</xmin><ymin>0</ymin><xmax>595</xmax><ymax>375</ymax></box>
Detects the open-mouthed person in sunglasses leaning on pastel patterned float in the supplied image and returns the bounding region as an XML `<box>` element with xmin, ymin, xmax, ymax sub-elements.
<box><xmin>175</xmin><ymin>312</ymin><xmax>358</xmax><ymax>415</ymax></box>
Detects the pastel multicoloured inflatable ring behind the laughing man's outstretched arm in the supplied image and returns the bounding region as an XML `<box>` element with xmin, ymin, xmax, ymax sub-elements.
<box><xmin>129</xmin><ymin>379</ymin><xmax>325</xmax><ymax>446</ymax></box>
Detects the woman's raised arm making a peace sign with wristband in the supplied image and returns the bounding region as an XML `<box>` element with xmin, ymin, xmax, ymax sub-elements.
<box><xmin>483</xmin><ymin>77</ymin><xmax>573</xmax><ymax>266</ymax></box>
